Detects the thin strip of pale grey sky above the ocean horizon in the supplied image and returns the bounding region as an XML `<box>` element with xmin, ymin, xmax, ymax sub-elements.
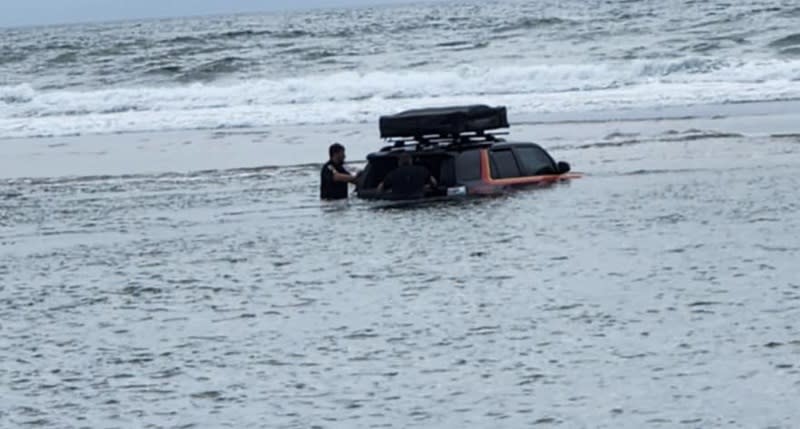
<box><xmin>0</xmin><ymin>0</ymin><xmax>424</xmax><ymax>27</ymax></box>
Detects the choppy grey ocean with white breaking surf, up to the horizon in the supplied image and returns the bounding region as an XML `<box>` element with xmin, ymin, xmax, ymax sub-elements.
<box><xmin>0</xmin><ymin>0</ymin><xmax>800</xmax><ymax>137</ymax></box>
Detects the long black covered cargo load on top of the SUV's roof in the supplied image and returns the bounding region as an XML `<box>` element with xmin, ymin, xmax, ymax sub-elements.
<box><xmin>380</xmin><ymin>105</ymin><xmax>509</xmax><ymax>139</ymax></box>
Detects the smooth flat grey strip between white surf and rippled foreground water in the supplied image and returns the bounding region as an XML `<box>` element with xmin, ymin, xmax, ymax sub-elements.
<box><xmin>0</xmin><ymin>101</ymin><xmax>800</xmax><ymax>180</ymax></box>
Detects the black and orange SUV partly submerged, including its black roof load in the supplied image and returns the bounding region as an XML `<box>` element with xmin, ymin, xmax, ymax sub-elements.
<box><xmin>356</xmin><ymin>105</ymin><xmax>580</xmax><ymax>200</ymax></box>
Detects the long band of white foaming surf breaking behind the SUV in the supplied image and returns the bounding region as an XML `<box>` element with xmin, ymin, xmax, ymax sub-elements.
<box><xmin>0</xmin><ymin>57</ymin><xmax>800</xmax><ymax>137</ymax></box>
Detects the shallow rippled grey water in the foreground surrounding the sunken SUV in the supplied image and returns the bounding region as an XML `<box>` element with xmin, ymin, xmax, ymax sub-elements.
<box><xmin>0</xmin><ymin>131</ymin><xmax>800</xmax><ymax>428</ymax></box>
